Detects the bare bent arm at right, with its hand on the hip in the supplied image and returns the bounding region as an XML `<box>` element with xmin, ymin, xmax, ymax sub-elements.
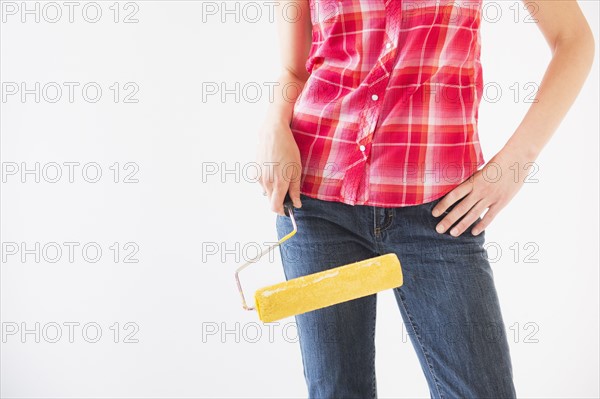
<box><xmin>432</xmin><ymin>0</ymin><xmax>595</xmax><ymax>236</ymax></box>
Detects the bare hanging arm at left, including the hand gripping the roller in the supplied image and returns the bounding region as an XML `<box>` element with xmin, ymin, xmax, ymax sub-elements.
<box><xmin>257</xmin><ymin>0</ymin><xmax>312</xmax><ymax>215</ymax></box>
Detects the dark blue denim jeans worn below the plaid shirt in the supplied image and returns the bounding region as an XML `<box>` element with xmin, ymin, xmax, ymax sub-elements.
<box><xmin>276</xmin><ymin>194</ymin><xmax>516</xmax><ymax>398</ymax></box>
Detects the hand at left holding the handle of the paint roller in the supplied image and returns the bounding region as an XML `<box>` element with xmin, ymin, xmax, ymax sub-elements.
<box><xmin>256</xmin><ymin>122</ymin><xmax>302</xmax><ymax>216</ymax></box>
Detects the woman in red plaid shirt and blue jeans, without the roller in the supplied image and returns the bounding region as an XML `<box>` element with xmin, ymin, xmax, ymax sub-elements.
<box><xmin>257</xmin><ymin>0</ymin><xmax>594</xmax><ymax>398</ymax></box>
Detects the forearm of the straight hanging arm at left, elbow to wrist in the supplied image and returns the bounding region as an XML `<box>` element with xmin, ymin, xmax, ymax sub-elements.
<box><xmin>265</xmin><ymin>69</ymin><xmax>306</xmax><ymax>130</ymax></box>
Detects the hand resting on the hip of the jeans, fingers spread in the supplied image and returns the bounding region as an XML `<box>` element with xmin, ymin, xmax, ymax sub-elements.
<box><xmin>431</xmin><ymin>147</ymin><xmax>533</xmax><ymax>237</ymax></box>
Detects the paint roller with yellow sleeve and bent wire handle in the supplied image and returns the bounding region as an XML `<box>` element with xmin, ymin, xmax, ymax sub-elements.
<box><xmin>235</xmin><ymin>194</ymin><xmax>403</xmax><ymax>323</ymax></box>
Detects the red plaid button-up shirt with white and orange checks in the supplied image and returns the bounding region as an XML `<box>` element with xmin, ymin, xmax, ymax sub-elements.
<box><xmin>290</xmin><ymin>0</ymin><xmax>484</xmax><ymax>207</ymax></box>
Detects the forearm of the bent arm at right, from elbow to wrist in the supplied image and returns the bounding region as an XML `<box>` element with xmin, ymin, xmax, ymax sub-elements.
<box><xmin>505</xmin><ymin>34</ymin><xmax>594</xmax><ymax>161</ymax></box>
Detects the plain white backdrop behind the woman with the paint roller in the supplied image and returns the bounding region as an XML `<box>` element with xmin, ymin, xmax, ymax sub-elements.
<box><xmin>1</xmin><ymin>1</ymin><xmax>600</xmax><ymax>398</ymax></box>
